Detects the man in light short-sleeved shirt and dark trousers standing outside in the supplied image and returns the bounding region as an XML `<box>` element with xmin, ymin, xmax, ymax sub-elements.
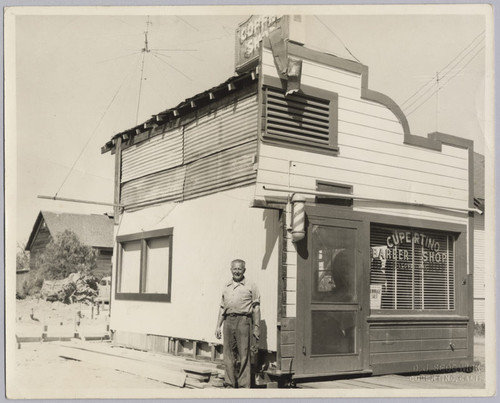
<box><xmin>215</xmin><ymin>259</ymin><xmax>260</xmax><ymax>388</ymax></box>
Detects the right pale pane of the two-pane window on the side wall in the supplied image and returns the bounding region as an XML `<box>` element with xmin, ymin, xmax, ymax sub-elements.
<box><xmin>144</xmin><ymin>237</ymin><xmax>170</xmax><ymax>294</ymax></box>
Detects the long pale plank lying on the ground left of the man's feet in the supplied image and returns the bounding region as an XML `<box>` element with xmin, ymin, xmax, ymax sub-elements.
<box><xmin>59</xmin><ymin>345</ymin><xmax>186</xmax><ymax>388</ymax></box>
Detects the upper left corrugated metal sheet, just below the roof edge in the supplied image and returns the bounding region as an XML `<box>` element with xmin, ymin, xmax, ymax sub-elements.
<box><xmin>121</xmin><ymin>128</ymin><xmax>182</xmax><ymax>183</ymax></box>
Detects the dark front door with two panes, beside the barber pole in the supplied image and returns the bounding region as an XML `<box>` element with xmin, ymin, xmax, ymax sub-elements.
<box><xmin>296</xmin><ymin>217</ymin><xmax>366</xmax><ymax>375</ymax></box>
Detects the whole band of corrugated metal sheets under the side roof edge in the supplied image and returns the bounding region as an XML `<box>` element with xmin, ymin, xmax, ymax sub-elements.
<box><xmin>120</xmin><ymin>93</ymin><xmax>258</xmax><ymax>208</ymax></box>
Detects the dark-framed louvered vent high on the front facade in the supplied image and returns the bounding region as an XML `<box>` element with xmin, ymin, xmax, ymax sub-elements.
<box><xmin>264</xmin><ymin>86</ymin><xmax>338</xmax><ymax>152</ymax></box>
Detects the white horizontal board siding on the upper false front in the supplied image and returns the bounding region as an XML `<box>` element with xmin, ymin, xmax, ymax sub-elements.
<box><xmin>257</xmin><ymin>50</ymin><xmax>469</xmax><ymax>218</ymax></box>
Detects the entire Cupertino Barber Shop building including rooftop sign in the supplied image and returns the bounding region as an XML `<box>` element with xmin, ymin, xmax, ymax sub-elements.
<box><xmin>103</xmin><ymin>16</ymin><xmax>475</xmax><ymax>386</ymax></box>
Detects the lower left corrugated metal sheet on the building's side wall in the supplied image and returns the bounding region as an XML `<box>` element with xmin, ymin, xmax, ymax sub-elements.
<box><xmin>121</xmin><ymin>166</ymin><xmax>186</xmax><ymax>206</ymax></box>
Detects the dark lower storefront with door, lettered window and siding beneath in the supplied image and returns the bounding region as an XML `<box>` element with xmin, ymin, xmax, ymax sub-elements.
<box><xmin>295</xmin><ymin>206</ymin><xmax>472</xmax><ymax>377</ymax></box>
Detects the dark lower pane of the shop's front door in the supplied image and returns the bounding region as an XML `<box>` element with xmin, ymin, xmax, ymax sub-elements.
<box><xmin>311</xmin><ymin>311</ymin><xmax>356</xmax><ymax>355</ymax></box>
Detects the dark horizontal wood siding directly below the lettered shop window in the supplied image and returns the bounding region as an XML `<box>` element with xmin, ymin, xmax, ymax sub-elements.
<box><xmin>369</xmin><ymin>323</ymin><xmax>469</xmax><ymax>366</ymax></box>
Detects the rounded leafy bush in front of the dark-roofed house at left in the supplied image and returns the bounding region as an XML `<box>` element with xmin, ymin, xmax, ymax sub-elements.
<box><xmin>38</xmin><ymin>230</ymin><xmax>97</xmax><ymax>280</ymax></box>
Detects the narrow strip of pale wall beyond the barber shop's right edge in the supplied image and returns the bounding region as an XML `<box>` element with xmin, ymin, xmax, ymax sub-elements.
<box><xmin>474</xmin><ymin>214</ymin><xmax>485</xmax><ymax>323</ymax></box>
